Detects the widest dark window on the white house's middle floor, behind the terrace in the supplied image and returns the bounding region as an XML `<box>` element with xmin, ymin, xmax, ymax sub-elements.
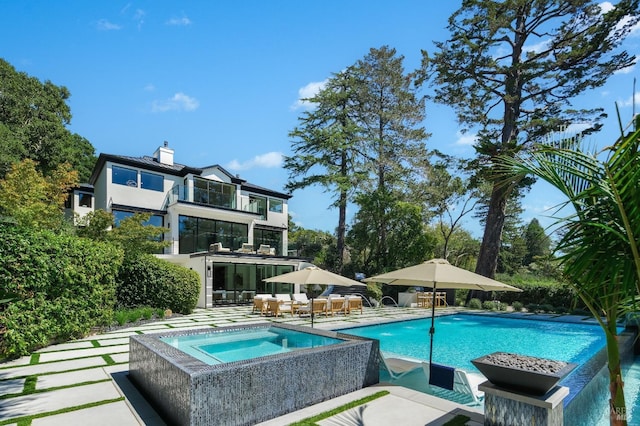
<box><xmin>179</xmin><ymin>215</ymin><xmax>249</xmax><ymax>254</ymax></box>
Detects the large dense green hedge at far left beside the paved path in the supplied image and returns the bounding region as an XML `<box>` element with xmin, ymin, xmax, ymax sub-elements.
<box><xmin>0</xmin><ymin>224</ymin><xmax>123</xmax><ymax>357</ymax></box>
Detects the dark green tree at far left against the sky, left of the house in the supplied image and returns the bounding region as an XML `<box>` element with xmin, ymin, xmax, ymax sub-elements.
<box><xmin>0</xmin><ymin>59</ymin><xmax>96</xmax><ymax>182</ymax></box>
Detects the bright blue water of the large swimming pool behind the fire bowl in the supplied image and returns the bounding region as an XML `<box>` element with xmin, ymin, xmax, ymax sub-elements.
<box><xmin>341</xmin><ymin>314</ymin><xmax>606</xmax><ymax>372</ymax></box>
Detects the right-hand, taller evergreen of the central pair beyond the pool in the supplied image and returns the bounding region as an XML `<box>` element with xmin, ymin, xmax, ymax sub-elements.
<box><xmin>354</xmin><ymin>46</ymin><xmax>429</xmax><ymax>266</ymax></box>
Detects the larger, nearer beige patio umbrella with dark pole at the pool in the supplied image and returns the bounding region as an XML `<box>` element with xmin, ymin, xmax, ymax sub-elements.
<box><xmin>363</xmin><ymin>259</ymin><xmax>522</xmax><ymax>365</ymax></box>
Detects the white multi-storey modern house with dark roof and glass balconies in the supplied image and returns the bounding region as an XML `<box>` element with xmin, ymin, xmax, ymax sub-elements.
<box><xmin>69</xmin><ymin>142</ymin><xmax>307</xmax><ymax>307</ymax></box>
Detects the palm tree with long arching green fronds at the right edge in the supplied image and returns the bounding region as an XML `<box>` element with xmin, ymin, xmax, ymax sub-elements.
<box><xmin>500</xmin><ymin>117</ymin><xmax>640</xmax><ymax>425</ymax></box>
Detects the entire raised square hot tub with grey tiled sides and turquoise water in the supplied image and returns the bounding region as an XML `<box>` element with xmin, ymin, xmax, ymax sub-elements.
<box><xmin>129</xmin><ymin>324</ymin><xmax>379</xmax><ymax>425</ymax></box>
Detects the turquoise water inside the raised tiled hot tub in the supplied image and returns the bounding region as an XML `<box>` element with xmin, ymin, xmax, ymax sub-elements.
<box><xmin>160</xmin><ymin>328</ymin><xmax>343</xmax><ymax>365</ymax></box>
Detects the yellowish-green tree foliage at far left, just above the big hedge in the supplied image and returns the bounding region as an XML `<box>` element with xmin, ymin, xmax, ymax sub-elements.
<box><xmin>0</xmin><ymin>159</ymin><xmax>78</xmax><ymax>230</ymax></box>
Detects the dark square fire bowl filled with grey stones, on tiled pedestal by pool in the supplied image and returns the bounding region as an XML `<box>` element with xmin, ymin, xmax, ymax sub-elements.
<box><xmin>471</xmin><ymin>352</ymin><xmax>576</xmax><ymax>395</ymax></box>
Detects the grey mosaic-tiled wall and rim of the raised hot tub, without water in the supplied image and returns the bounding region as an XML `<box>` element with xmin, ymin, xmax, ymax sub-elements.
<box><xmin>129</xmin><ymin>325</ymin><xmax>379</xmax><ymax>425</ymax></box>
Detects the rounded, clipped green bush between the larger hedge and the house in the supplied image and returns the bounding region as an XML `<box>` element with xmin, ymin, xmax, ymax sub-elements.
<box><xmin>117</xmin><ymin>255</ymin><xmax>200</xmax><ymax>314</ymax></box>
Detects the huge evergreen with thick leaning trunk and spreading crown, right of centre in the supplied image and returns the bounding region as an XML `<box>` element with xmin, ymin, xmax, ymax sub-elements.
<box><xmin>423</xmin><ymin>0</ymin><xmax>638</xmax><ymax>277</ymax></box>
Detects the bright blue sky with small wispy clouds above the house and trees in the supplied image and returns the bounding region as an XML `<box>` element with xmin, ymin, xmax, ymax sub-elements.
<box><xmin>0</xmin><ymin>0</ymin><xmax>640</xmax><ymax>237</ymax></box>
